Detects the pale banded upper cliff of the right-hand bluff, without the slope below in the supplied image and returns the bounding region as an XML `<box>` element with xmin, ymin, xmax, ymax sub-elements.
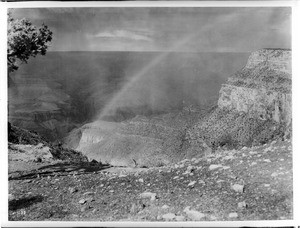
<box><xmin>218</xmin><ymin>49</ymin><xmax>292</xmax><ymax>125</ymax></box>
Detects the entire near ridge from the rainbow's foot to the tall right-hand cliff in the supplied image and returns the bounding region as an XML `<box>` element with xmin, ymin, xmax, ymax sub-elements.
<box><xmin>65</xmin><ymin>49</ymin><xmax>291</xmax><ymax>167</ymax></box>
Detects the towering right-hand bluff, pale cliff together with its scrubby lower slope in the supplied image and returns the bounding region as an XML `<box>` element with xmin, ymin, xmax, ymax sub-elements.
<box><xmin>188</xmin><ymin>49</ymin><xmax>292</xmax><ymax>148</ymax></box>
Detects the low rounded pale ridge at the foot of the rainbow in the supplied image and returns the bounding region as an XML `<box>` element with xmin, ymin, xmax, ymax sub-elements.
<box><xmin>65</xmin><ymin>111</ymin><xmax>210</xmax><ymax>167</ymax></box>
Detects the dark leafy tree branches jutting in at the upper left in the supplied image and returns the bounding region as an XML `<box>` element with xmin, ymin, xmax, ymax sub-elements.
<box><xmin>7</xmin><ymin>12</ymin><xmax>52</xmax><ymax>73</ymax></box>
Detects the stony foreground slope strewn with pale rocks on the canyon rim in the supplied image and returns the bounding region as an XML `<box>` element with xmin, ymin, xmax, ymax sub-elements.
<box><xmin>9</xmin><ymin>141</ymin><xmax>293</xmax><ymax>221</ymax></box>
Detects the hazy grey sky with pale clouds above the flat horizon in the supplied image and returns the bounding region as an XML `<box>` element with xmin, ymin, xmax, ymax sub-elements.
<box><xmin>13</xmin><ymin>7</ymin><xmax>291</xmax><ymax>52</ymax></box>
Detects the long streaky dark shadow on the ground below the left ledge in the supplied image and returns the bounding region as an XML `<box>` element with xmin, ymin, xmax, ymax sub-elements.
<box><xmin>8</xmin><ymin>162</ymin><xmax>111</xmax><ymax>180</ymax></box>
